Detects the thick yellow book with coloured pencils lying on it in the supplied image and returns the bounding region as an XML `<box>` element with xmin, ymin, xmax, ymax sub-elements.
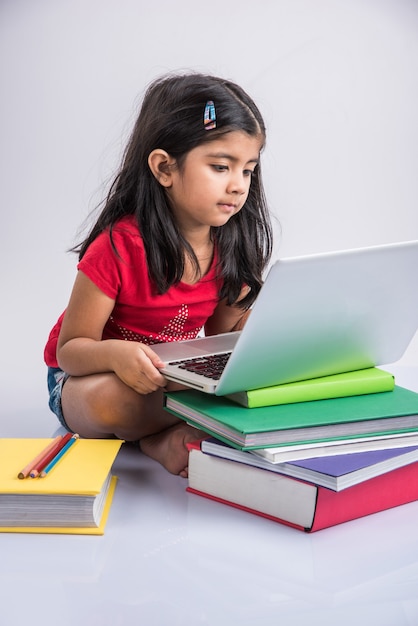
<box><xmin>0</xmin><ymin>438</ymin><xmax>123</xmax><ymax>535</ymax></box>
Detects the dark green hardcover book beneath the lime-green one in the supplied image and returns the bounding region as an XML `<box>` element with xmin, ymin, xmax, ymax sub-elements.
<box><xmin>164</xmin><ymin>385</ymin><xmax>418</xmax><ymax>450</ymax></box>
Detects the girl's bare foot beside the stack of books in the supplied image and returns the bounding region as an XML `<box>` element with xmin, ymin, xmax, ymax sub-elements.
<box><xmin>139</xmin><ymin>422</ymin><xmax>208</xmax><ymax>478</ymax></box>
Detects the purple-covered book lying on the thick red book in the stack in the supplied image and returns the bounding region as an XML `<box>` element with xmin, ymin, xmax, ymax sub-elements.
<box><xmin>201</xmin><ymin>438</ymin><xmax>418</xmax><ymax>491</ymax></box>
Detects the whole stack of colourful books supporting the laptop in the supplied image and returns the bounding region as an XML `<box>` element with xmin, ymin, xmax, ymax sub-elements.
<box><xmin>165</xmin><ymin>368</ymin><xmax>418</xmax><ymax>532</ymax></box>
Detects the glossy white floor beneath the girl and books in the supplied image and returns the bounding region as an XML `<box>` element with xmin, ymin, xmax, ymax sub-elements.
<box><xmin>0</xmin><ymin>360</ymin><xmax>418</xmax><ymax>626</ymax></box>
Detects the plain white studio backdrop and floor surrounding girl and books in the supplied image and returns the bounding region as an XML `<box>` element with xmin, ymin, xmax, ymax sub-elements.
<box><xmin>0</xmin><ymin>7</ymin><xmax>418</xmax><ymax>626</ymax></box>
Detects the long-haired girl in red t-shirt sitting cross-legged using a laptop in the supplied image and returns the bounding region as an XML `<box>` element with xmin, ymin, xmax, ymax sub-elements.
<box><xmin>45</xmin><ymin>74</ymin><xmax>272</xmax><ymax>477</ymax></box>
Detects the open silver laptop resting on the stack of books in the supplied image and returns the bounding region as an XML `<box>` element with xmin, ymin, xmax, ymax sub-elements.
<box><xmin>152</xmin><ymin>241</ymin><xmax>418</xmax><ymax>395</ymax></box>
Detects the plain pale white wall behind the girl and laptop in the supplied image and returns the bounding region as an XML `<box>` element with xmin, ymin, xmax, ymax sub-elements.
<box><xmin>0</xmin><ymin>0</ymin><xmax>418</xmax><ymax>420</ymax></box>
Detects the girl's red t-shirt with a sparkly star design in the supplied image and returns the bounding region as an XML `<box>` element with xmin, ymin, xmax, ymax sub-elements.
<box><xmin>44</xmin><ymin>216</ymin><xmax>221</xmax><ymax>367</ymax></box>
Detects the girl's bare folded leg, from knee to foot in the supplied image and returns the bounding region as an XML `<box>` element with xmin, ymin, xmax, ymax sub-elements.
<box><xmin>62</xmin><ymin>373</ymin><xmax>203</xmax><ymax>477</ymax></box>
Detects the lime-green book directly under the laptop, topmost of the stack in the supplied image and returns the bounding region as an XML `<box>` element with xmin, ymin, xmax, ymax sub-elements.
<box><xmin>227</xmin><ymin>367</ymin><xmax>395</xmax><ymax>409</ymax></box>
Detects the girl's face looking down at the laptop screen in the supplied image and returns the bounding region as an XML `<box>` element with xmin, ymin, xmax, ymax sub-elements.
<box><xmin>167</xmin><ymin>131</ymin><xmax>262</xmax><ymax>233</ymax></box>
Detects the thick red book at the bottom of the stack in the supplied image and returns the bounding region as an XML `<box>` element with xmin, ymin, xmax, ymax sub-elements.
<box><xmin>187</xmin><ymin>444</ymin><xmax>418</xmax><ymax>532</ymax></box>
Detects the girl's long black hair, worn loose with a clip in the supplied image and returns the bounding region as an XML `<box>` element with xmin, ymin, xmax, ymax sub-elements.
<box><xmin>73</xmin><ymin>73</ymin><xmax>272</xmax><ymax>308</ymax></box>
